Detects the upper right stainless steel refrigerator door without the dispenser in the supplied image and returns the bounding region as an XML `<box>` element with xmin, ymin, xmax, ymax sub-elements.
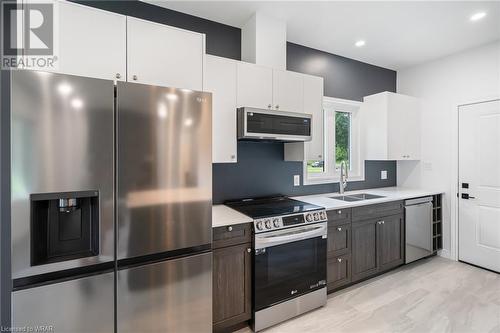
<box><xmin>117</xmin><ymin>82</ymin><xmax>212</xmax><ymax>259</ymax></box>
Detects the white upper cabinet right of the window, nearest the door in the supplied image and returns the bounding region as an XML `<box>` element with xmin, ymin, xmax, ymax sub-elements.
<box><xmin>360</xmin><ymin>92</ymin><xmax>421</xmax><ymax>160</ymax></box>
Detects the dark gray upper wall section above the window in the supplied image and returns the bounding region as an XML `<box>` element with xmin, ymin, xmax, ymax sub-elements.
<box><xmin>286</xmin><ymin>43</ymin><xmax>396</xmax><ymax>101</ymax></box>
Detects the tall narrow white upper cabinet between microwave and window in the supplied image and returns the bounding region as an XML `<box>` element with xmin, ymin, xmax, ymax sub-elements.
<box><xmin>303</xmin><ymin>75</ymin><xmax>325</xmax><ymax>161</ymax></box>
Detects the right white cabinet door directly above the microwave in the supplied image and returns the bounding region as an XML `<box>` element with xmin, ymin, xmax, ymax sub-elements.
<box><xmin>272</xmin><ymin>69</ymin><xmax>307</xmax><ymax>113</ymax></box>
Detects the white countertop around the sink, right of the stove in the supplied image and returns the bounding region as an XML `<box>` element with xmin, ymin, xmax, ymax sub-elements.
<box><xmin>292</xmin><ymin>187</ymin><xmax>444</xmax><ymax>210</ymax></box>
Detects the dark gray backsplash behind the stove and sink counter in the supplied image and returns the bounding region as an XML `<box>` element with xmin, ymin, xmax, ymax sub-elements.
<box><xmin>213</xmin><ymin>141</ymin><xmax>396</xmax><ymax>203</ymax></box>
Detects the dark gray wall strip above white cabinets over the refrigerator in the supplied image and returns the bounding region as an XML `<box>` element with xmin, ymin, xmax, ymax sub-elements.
<box><xmin>73</xmin><ymin>0</ymin><xmax>241</xmax><ymax>60</ymax></box>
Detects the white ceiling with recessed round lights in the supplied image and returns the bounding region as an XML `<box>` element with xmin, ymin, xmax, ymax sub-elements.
<box><xmin>146</xmin><ymin>0</ymin><xmax>500</xmax><ymax>69</ymax></box>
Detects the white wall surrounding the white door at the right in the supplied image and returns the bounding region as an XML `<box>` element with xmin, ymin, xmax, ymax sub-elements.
<box><xmin>397</xmin><ymin>41</ymin><xmax>500</xmax><ymax>257</ymax></box>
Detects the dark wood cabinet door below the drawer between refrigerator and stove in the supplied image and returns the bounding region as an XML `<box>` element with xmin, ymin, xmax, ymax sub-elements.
<box><xmin>212</xmin><ymin>230</ymin><xmax>252</xmax><ymax>332</ymax></box>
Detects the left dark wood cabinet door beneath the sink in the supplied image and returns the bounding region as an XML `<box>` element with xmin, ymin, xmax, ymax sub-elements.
<box><xmin>352</xmin><ymin>220</ymin><xmax>378</xmax><ymax>281</ymax></box>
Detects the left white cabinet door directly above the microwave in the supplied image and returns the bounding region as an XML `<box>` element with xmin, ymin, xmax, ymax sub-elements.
<box><xmin>237</xmin><ymin>62</ymin><xmax>273</xmax><ymax>109</ymax></box>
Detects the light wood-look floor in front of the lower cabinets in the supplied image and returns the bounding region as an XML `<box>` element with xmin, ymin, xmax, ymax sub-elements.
<box><xmin>238</xmin><ymin>257</ymin><xmax>500</xmax><ymax>333</ymax></box>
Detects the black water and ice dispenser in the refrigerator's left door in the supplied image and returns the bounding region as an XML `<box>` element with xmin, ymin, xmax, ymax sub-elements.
<box><xmin>30</xmin><ymin>191</ymin><xmax>99</xmax><ymax>266</ymax></box>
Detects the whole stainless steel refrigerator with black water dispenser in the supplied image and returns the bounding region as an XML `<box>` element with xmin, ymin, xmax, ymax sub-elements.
<box><xmin>11</xmin><ymin>71</ymin><xmax>212</xmax><ymax>332</ymax></box>
